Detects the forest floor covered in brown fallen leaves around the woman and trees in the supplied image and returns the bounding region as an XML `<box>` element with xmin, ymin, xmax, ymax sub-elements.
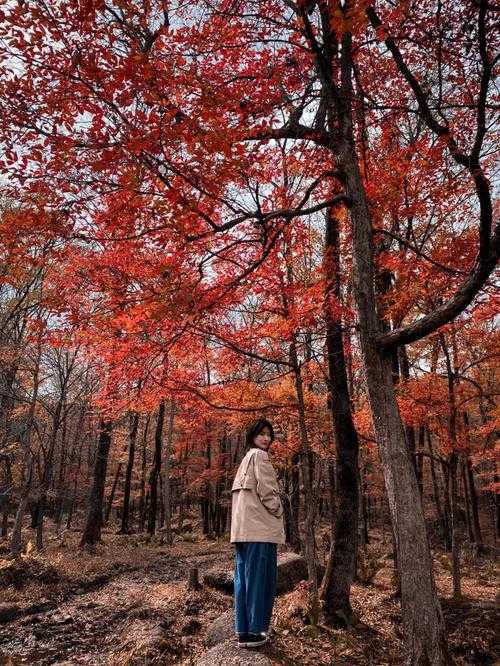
<box><xmin>0</xmin><ymin>520</ymin><xmax>500</xmax><ymax>666</ymax></box>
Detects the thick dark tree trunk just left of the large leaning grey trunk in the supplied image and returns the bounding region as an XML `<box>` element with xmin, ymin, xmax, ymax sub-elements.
<box><xmin>321</xmin><ymin>211</ymin><xmax>359</xmax><ymax>625</ymax></box>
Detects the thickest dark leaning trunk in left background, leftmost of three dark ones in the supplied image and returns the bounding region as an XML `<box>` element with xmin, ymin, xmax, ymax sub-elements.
<box><xmin>80</xmin><ymin>419</ymin><xmax>112</xmax><ymax>548</ymax></box>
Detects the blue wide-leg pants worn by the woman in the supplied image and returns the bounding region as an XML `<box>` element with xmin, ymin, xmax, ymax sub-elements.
<box><xmin>234</xmin><ymin>541</ymin><xmax>278</xmax><ymax>634</ymax></box>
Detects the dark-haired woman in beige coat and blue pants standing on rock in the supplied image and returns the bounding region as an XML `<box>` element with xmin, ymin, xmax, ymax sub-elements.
<box><xmin>231</xmin><ymin>419</ymin><xmax>285</xmax><ymax>647</ymax></box>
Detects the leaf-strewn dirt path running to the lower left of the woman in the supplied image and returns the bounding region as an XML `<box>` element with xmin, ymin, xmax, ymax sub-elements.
<box><xmin>0</xmin><ymin>551</ymin><xmax>232</xmax><ymax>666</ymax></box>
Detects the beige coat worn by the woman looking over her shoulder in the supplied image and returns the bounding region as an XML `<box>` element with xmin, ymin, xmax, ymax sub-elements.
<box><xmin>231</xmin><ymin>448</ymin><xmax>285</xmax><ymax>543</ymax></box>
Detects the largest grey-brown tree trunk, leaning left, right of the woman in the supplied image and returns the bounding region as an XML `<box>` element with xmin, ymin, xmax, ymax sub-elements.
<box><xmin>338</xmin><ymin>42</ymin><xmax>448</xmax><ymax>666</ymax></box>
